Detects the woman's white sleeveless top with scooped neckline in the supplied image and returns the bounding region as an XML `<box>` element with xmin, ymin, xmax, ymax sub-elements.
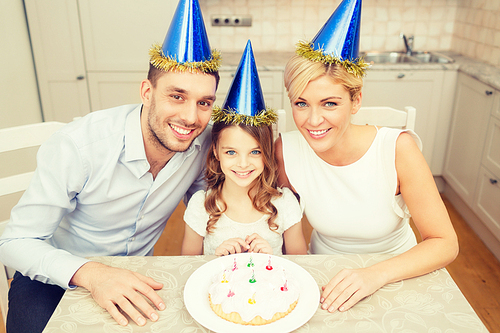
<box><xmin>281</xmin><ymin>127</ymin><xmax>422</xmax><ymax>254</ymax></box>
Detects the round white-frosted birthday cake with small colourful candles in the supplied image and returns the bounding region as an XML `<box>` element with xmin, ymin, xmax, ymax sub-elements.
<box><xmin>208</xmin><ymin>256</ymin><xmax>299</xmax><ymax>325</ymax></box>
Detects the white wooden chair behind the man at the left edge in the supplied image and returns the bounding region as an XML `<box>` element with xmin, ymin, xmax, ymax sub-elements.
<box><xmin>0</xmin><ymin>122</ymin><xmax>65</xmax><ymax>323</ymax></box>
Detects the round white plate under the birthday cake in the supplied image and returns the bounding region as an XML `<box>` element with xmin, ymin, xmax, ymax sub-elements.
<box><xmin>184</xmin><ymin>253</ymin><xmax>320</xmax><ymax>333</ymax></box>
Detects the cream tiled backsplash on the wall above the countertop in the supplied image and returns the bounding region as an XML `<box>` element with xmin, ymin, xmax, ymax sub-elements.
<box><xmin>200</xmin><ymin>0</ymin><xmax>500</xmax><ymax>66</ymax></box>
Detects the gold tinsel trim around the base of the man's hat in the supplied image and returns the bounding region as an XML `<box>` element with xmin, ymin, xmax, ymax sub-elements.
<box><xmin>149</xmin><ymin>44</ymin><xmax>221</xmax><ymax>73</ymax></box>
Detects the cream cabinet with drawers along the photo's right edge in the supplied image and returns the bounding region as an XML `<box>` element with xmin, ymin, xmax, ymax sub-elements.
<box><xmin>443</xmin><ymin>73</ymin><xmax>500</xmax><ymax>249</ymax></box>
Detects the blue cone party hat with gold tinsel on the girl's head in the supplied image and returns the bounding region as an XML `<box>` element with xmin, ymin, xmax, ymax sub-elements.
<box><xmin>212</xmin><ymin>40</ymin><xmax>278</xmax><ymax>126</ymax></box>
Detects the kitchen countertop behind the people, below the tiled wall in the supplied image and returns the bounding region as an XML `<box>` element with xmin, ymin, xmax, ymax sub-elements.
<box><xmin>220</xmin><ymin>51</ymin><xmax>500</xmax><ymax>90</ymax></box>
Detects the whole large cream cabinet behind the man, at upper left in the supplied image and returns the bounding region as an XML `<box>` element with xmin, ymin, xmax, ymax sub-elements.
<box><xmin>24</xmin><ymin>0</ymin><xmax>178</xmax><ymax>122</ymax></box>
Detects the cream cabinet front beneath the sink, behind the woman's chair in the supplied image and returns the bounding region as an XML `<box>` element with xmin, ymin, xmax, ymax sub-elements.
<box><xmin>362</xmin><ymin>70</ymin><xmax>445</xmax><ymax>175</ymax></box>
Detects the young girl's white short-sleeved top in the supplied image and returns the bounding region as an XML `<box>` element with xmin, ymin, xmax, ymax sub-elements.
<box><xmin>184</xmin><ymin>188</ymin><xmax>302</xmax><ymax>255</ymax></box>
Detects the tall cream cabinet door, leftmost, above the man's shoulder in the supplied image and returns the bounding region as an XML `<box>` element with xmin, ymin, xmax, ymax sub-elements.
<box><xmin>24</xmin><ymin>0</ymin><xmax>90</xmax><ymax>122</ymax></box>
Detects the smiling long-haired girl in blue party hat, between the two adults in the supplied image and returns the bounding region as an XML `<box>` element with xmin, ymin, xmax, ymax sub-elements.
<box><xmin>181</xmin><ymin>43</ymin><xmax>307</xmax><ymax>256</ymax></box>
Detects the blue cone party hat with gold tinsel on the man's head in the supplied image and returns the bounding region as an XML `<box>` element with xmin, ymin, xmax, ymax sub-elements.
<box><xmin>149</xmin><ymin>0</ymin><xmax>220</xmax><ymax>72</ymax></box>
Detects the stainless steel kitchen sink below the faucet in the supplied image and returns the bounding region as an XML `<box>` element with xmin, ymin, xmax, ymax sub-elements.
<box><xmin>360</xmin><ymin>51</ymin><xmax>455</xmax><ymax>64</ymax></box>
